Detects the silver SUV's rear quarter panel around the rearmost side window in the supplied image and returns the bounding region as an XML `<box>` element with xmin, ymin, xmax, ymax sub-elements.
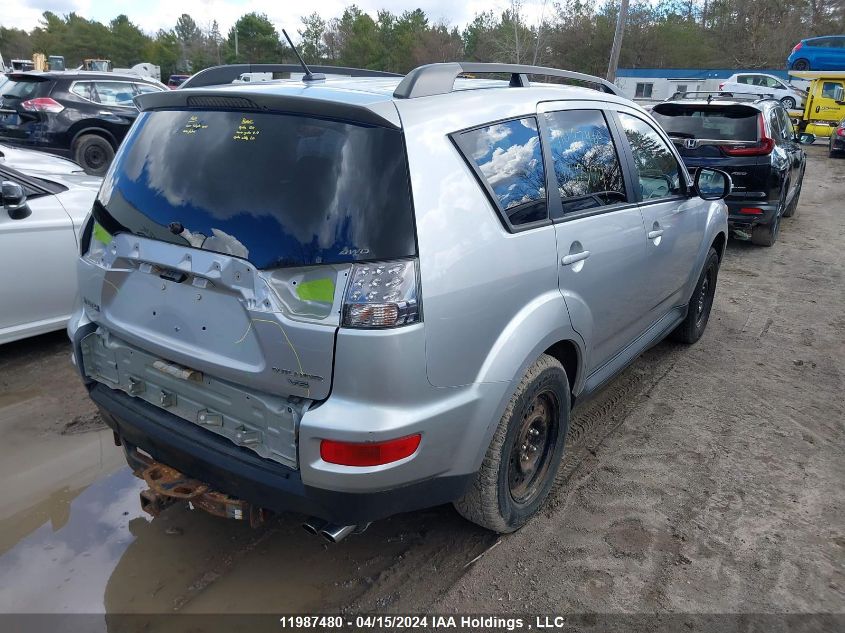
<box><xmin>397</xmin><ymin>90</ymin><xmax>580</xmax><ymax>391</ymax></box>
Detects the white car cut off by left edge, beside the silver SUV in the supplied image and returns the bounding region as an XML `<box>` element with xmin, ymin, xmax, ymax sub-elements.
<box><xmin>0</xmin><ymin>144</ymin><xmax>101</xmax><ymax>344</ymax></box>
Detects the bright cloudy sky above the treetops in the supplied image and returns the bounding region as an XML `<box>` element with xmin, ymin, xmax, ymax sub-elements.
<box><xmin>0</xmin><ymin>0</ymin><xmax>552</xmax><ymax>36</ymax></box>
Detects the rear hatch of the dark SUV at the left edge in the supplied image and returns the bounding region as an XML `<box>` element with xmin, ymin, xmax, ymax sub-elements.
<box><xmin>0</xmin><ymin>73</ymin><xmax>54</xmax><ymax>142</ymax></box>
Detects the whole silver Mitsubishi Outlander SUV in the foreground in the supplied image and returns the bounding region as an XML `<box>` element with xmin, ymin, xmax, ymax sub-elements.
<box><xmin>68</xmin><ymin>63</ymin><xmax>731</xmax><ymax>540</ymax></box>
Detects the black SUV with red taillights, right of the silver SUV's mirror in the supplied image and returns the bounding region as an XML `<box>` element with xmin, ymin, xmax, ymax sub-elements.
<box><xmin>652</xmin><ymin>92</ymin><xmax>806</xmax><ymax>246</ymax></box>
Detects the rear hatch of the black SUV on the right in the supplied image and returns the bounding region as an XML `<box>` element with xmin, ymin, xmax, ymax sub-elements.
<box><xmin>652</xmin><ymin>101</ymin><xmax>772</xmax><ymax>198</ymax></box>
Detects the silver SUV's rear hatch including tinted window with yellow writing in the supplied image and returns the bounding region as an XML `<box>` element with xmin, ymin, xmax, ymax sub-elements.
<box><xmin>85</xmin><ymin>109</ymin><xmax>416</xmax><ymax>400</ymax></box>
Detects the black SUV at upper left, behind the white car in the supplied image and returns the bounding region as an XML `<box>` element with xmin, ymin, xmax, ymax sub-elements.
<box><xmin>0</xmin><ymin>71</ymin><xmax>167</xmax><ymax>176</ymax></box>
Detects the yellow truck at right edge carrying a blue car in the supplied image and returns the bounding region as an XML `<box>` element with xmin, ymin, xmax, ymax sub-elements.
<box><xmin>789</xmin><ymin>70</ymin><xmax>845</xmax><ymax>137</ymax></box>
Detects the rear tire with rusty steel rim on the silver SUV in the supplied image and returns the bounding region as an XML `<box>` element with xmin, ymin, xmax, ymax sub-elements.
<box><xmin>454</xmin><ymin>354</ymin><xmax>570</xmax><ymax>534</ymax></box>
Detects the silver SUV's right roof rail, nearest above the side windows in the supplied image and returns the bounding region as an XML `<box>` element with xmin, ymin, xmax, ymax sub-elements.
<box><xmin>393</xmin><ymin>62</ymin><xmax>624</xmax><ymax>99</ymax></box>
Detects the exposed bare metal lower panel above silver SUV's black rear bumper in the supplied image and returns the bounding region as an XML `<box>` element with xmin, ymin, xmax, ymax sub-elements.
<box><xmin>81</xmin><ymin>328</ymin><xmax>300</xmax><ymax>468</ymax></box>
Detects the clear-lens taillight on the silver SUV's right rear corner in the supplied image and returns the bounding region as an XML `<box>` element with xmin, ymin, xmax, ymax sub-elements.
<box><xmin>342</xmin><ymin>260</ymin><xmax>420</xmax><ymax>328</ymax></box>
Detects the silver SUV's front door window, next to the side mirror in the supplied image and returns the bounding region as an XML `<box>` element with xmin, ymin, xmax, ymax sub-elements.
<box><xmin>619</xmin><ymin>113</ymin><xmax>685</xmax><ymax>200</ymax></box>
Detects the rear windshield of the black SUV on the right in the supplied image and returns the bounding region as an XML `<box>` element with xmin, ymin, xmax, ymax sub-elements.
<box><xmin>652</xmin><ymin>103</ymin><xmax>760</xmax><ymax>141</ymax></box>
